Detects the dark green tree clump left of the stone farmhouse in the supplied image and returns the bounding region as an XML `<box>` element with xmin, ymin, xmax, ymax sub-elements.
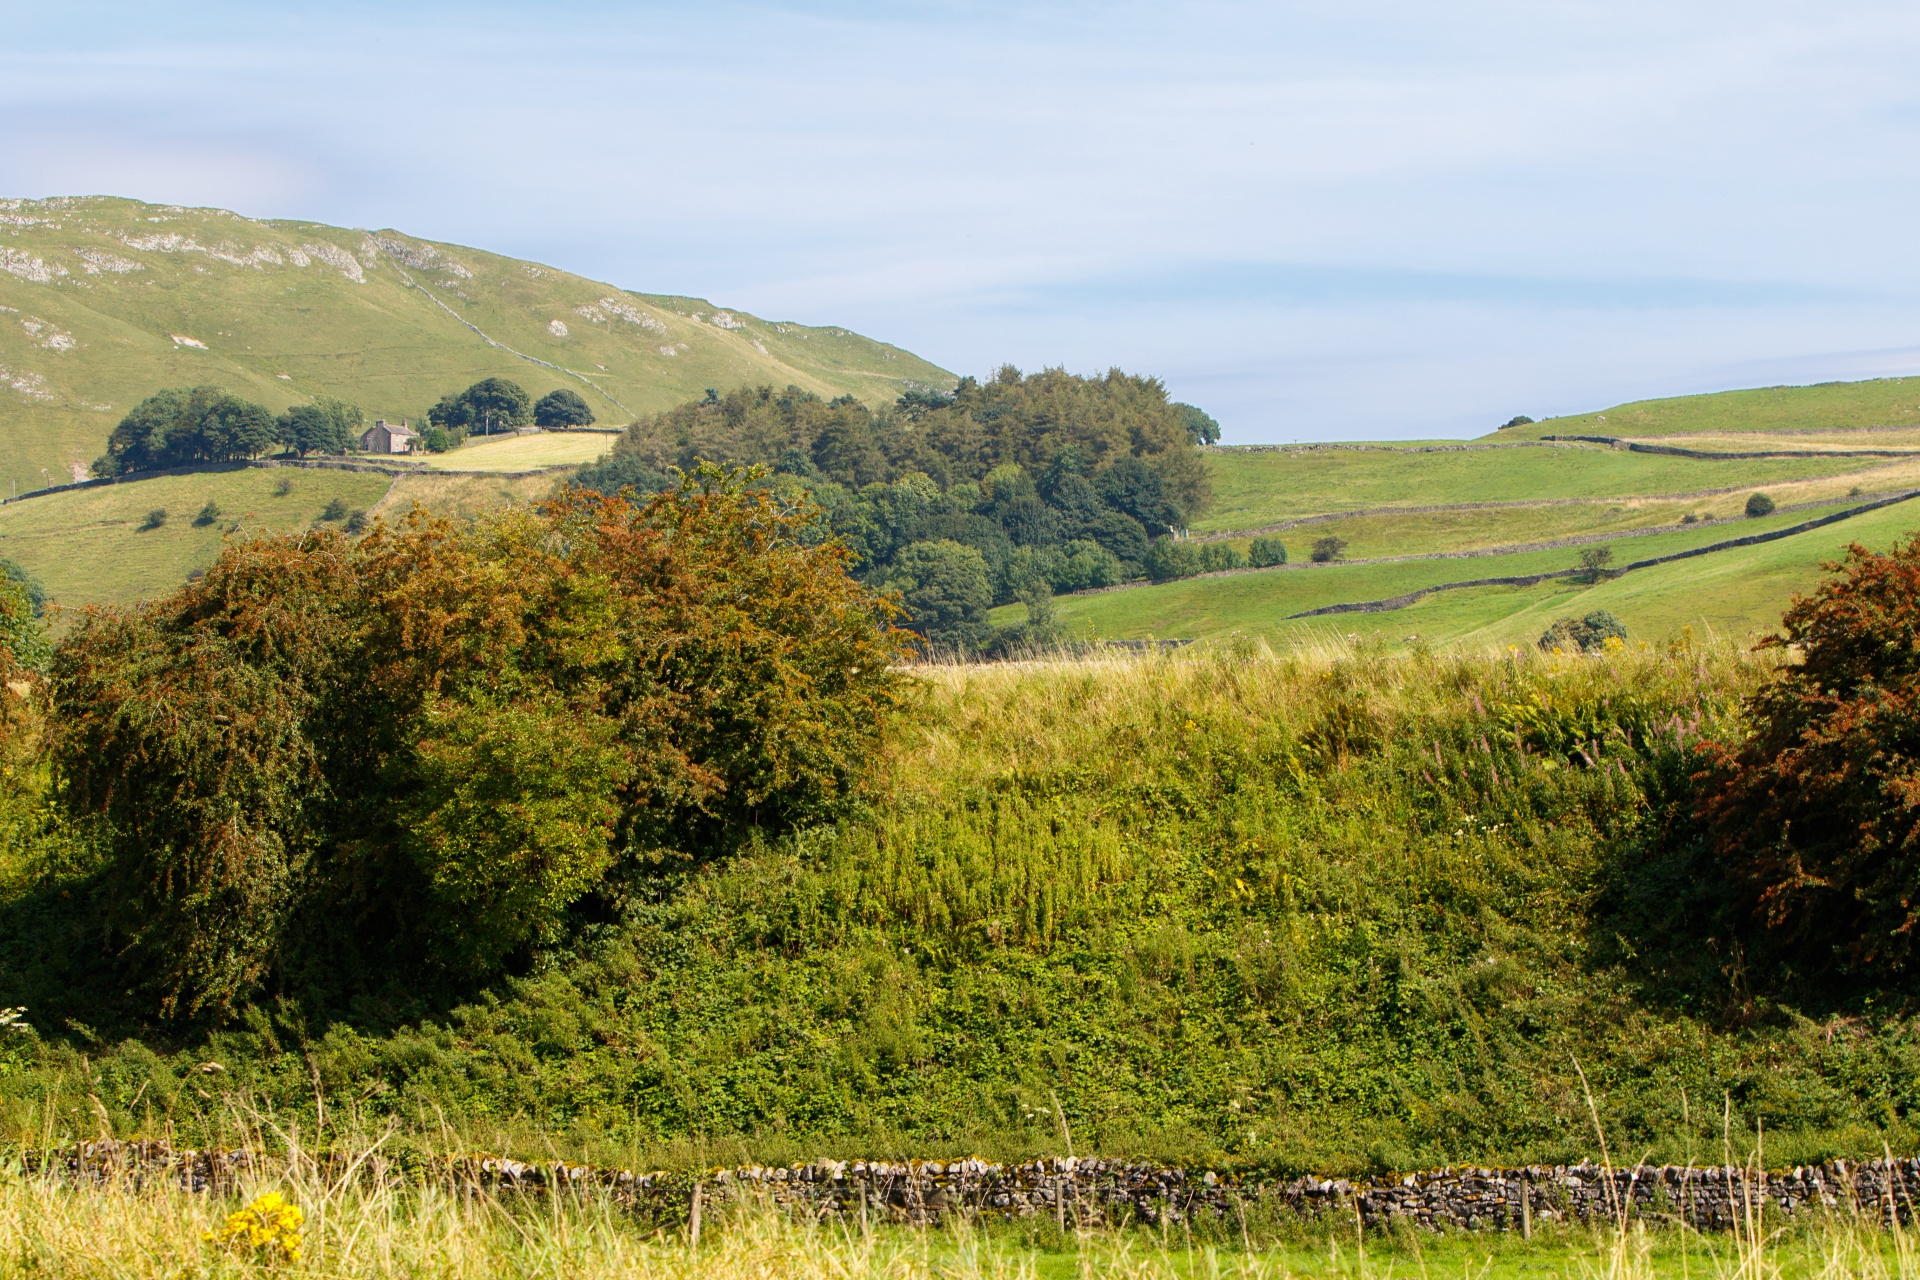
<box><xmin>92</xmin><ymin>386</ymin><xmax>367</xmax><ymax>476</ymax></box>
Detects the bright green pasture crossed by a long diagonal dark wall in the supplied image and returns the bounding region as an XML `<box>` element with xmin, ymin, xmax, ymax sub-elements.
<box><xmin>1021</xmin><ymin>503</ymin><xmax>1920</xmax><ymax>645</ymax></box>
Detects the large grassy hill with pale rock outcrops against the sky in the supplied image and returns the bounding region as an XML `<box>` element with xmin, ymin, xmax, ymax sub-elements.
<box><xmin>0</xmin><ymin>198</ymin><xmax>952</xmax><ymax>493</ymax></box>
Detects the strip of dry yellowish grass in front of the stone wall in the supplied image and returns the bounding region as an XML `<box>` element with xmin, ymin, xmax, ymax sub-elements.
<box><xmin>11</xmin><ymin>1161</ymin><xmax>1920</xmax><ymax>1280</ymax></box>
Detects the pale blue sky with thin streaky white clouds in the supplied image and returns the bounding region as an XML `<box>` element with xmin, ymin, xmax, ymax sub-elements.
<box><xmin>0</xmin><ymin>0</ymin><xmax>1920</xmax><ymax>443</ymax></box>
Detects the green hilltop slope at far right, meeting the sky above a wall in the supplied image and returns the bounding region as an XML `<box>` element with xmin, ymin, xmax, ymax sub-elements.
<box><xmin>1482</xmin><ymin>378</ymin><xmax>1920</xmax><ymax>439</ymax></box>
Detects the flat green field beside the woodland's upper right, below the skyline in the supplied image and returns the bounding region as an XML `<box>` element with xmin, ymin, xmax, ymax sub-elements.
<box><xmin>1192</xmin><ymin>445</ymin><xmax>1873</xmax><ymax>533</ymax></box>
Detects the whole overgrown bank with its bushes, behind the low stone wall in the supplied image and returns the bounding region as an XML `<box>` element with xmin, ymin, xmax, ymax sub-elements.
<box><xmin>0</xmin><ymin>498</ymin><xmax>1920</xmax><ymax>1173</ymax></box>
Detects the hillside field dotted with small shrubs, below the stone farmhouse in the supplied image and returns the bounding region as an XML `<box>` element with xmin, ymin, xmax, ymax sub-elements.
<box><xmin>0</xmin><ymin>466</ymin><xmax>392</xmax><ymax>606</ymax></box>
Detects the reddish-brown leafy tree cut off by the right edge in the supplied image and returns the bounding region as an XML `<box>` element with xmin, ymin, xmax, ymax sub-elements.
<box><xmin>1701</xmin><ymin>535</ymin><xmax>1920</xmax><ymax>975</ymax></box>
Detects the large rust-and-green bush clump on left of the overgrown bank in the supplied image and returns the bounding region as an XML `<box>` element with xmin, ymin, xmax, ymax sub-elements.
<box><xmin>54</xmin><ymin>470</ymin><xmax>902</xmax><ymax>1015</ymax></box>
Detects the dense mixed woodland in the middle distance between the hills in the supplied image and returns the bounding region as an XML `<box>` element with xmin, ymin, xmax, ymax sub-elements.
<box><xmin>576</xmin><ymin>367</ymin><xmax>1244</xmax><ymax>651</ymax></box>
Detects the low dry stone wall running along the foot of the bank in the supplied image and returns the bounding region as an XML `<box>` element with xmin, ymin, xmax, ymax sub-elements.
<box><xmin>21</xmin><ymin>1142</ymin><xmax>1920</xmax><ymax>1232</ymax></box>
